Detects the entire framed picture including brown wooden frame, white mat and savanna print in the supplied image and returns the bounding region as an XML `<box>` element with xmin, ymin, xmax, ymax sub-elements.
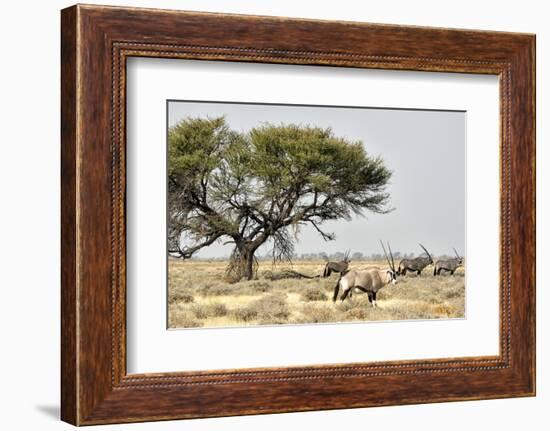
<box><xmin>61</xmin><ymin>5</ymin><xmax>535</xmax><ymax>425</ymax></box>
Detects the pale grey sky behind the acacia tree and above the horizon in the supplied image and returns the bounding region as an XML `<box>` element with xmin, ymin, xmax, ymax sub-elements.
<box><xmin>168</xmin><ymin>101</ymin><xmax>466</xmax><ymax>257</ymax></box>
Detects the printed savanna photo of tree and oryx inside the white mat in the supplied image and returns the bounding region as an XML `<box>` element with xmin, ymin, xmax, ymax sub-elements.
<box><xmin>166</xmin><ymin>100</ymin><xmax>466</xmax><ymax>329</ymax></box>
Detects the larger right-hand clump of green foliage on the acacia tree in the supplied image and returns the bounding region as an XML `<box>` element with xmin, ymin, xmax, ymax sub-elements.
<box><xmin>249</xmin><ymin>124</ymin><xmax>391</xmax><ymax>221</ymax></box>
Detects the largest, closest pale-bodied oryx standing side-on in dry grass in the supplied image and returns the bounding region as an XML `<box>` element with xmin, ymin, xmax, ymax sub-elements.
<box><xmin>332</xmin><ymin>241</ymin><xmax>397</xmax><ymax>307</ymax></box>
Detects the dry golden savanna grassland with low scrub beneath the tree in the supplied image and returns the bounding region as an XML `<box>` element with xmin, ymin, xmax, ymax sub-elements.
<box><xmin>168</xmin><ymin>259</ymin><xmax>465</xmax><ymax>328</ymax></box>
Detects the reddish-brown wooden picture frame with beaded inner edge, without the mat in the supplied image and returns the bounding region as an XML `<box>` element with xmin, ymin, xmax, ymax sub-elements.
<box><xmin>61</xmin><ymin>5</ymin><xmax>535</xmax><ymax>425</ymax></box>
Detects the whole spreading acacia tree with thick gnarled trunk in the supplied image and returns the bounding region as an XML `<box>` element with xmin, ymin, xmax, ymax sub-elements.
<box><xmin>168</xmin><ymin>117</ymin><xmax>391</xmax><ymax>280</ymax></box>
